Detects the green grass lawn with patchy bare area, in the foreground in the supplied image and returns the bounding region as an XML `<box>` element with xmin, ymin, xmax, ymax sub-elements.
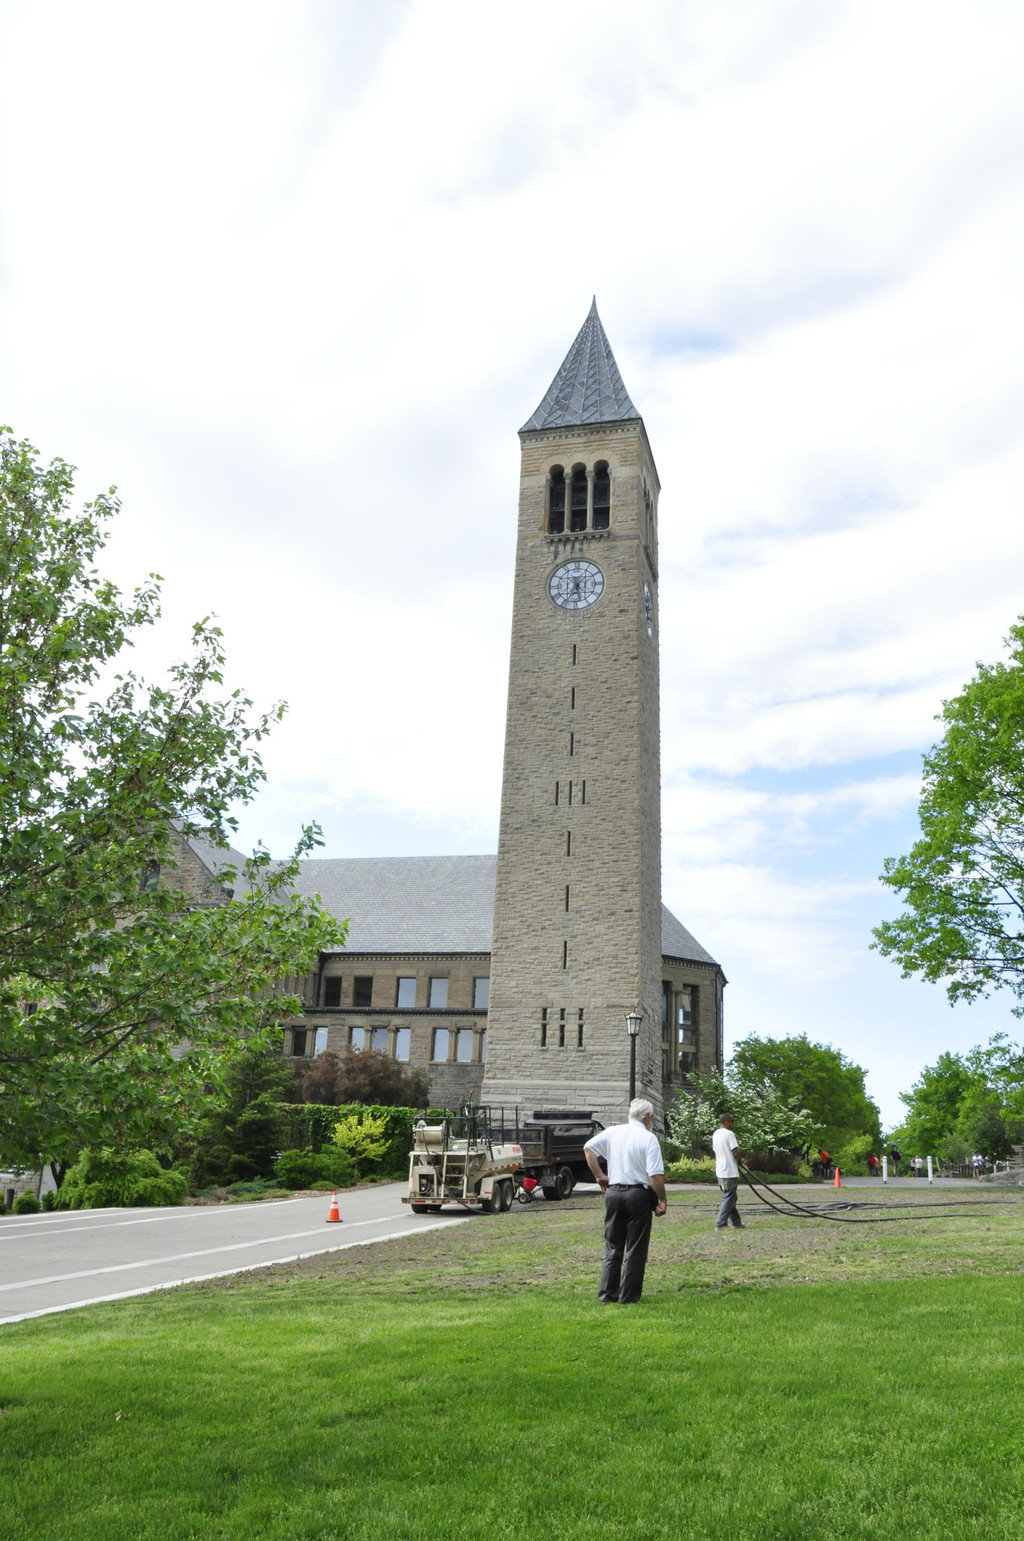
<box><xmin>0</xmin><ymin>1190</ymin><xmax>1024</xmax><ymax>1541</ymax></box>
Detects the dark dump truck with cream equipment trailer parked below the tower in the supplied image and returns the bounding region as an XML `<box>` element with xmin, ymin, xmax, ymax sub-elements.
<box><xmin>402</xmin><ymin>1106</ymin><xmax>604</xmax><ymax>1214</ymax></box>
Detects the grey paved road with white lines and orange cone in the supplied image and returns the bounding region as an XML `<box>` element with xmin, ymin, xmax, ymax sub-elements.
<box><xmin>0</xmin><ymin>1182</ymin><xmax>467</xmax><ymax>1324</ymax></box>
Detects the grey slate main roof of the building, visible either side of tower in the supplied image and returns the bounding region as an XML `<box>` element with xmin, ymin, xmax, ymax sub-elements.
<box><xmin>275</xmin><ymin>855</ymin><xmax>714</xmax><ymax>965</ymax></box>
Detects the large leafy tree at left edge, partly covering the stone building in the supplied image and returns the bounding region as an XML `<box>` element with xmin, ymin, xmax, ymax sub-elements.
<box><xmin>0</xmin><ymin>430</ymin><xmax>343</xmax><ymax>1179</ymax></box>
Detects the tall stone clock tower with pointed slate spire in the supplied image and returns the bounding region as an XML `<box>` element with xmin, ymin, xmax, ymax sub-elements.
<box><xmin>480</xmin><ymin>304</ymin><xmax>662</xmax><ymax>1122</ymax></box>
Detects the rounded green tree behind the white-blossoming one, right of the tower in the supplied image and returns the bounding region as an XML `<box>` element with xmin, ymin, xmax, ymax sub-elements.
<box><xmin>730</xmin><ymin>1034</ymin><xmax>882</xmax><ymax>1150</ymax></box>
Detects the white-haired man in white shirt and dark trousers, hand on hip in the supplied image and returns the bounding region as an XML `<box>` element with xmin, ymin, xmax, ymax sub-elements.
<box><xmin>584</xmin><ymin>1097</ymin><xmax>668</xmax><ymax>1305</ymax></box>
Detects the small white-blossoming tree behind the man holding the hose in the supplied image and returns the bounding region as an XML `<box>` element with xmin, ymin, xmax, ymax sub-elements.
<box><xmin>665</xmin><ymin>1071</ymin><xmax>815</xmax><ymax>1153</ymax></box>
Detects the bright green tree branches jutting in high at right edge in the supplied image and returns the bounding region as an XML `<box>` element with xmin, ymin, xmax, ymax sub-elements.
<box><xmin>873</xmin><ymin>616</ymin><xmax>1024</xmax><ymax>1016</ymax></box>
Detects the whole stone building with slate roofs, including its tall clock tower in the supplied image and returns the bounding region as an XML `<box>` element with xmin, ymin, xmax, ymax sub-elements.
<box><xmin>255</xmin><ymin>305</ymin><xmax>725</xmax><ymax>1117</ymax></box>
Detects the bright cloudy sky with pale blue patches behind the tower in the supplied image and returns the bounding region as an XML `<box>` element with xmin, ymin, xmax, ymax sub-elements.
<box><xmin>0</xmin><ymin>0</ymin><xmax>1024</xmax><ymax>1123</ymax></box>
